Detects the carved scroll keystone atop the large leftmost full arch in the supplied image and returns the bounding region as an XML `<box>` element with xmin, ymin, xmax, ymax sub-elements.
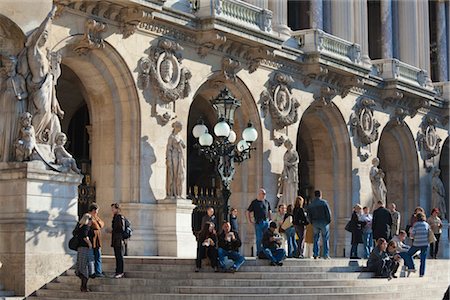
<box><xmin>73</xmin><ymin>19</ymin><xmax>106</xmax><ymax>55</ymax></box>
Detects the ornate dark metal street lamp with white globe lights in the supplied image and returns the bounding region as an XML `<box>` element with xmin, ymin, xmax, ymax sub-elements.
<box><xmin>192</xmin><ymin>88</ymin><xmax>258</xmax><ymax>220</ymax></box>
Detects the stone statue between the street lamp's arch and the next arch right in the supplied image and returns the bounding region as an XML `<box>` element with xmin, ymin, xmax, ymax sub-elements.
<box><xmin>280</xmin><ymin>139</ymin><xmax>300</xmax><ymax>204</ymax></box>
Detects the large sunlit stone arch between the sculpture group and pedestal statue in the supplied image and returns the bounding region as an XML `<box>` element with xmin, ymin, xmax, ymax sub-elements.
<box><xmin>55</xmin><ymin>43</ymin><xmax>140</xmax><ymax>207</ymax></box>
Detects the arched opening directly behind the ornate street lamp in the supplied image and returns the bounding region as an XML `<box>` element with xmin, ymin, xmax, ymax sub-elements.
<box><xmin>187</xmin><ymin>75</ymin><xmax>262</xmax><ymax>255</ymax></box>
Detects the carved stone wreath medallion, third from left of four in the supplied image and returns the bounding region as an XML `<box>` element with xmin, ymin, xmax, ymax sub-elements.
<box><xmin>351</xmin><ymin>99</ymin><xmax>380</xmax><ymax>145</ymax></box>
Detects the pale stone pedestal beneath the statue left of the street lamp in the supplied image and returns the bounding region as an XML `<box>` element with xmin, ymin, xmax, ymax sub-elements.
<box><xmin>155</xmin><ymin>198</ymin><xmax>197</xmax><ymax>258</ymax></box>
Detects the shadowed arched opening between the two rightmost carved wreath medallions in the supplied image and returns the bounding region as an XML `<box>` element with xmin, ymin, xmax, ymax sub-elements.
<box><xmin>378</xmin><ymin>123</ymin><xmax>419</xmax><ymax>228</ymax></box>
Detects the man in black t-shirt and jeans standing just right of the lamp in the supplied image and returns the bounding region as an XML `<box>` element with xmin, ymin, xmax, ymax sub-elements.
<box><xmin>246</xmin><ymin>188</ymin><xmax>272</xmax><ymax>256</ymax></box>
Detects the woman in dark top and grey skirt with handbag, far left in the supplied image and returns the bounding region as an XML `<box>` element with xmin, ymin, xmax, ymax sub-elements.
<box><xmin>75</xmin><ymin>214</ymin><xmax>94</xmax><ymax>292</ymax></box>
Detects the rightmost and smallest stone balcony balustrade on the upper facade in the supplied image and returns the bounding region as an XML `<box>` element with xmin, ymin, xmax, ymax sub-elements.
<box><xmin>372</xmin><ymin>58</ymin><xmax>433</xmax><ymax>89</ymax></box>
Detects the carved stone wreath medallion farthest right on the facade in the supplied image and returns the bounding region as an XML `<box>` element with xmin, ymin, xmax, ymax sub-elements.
<box><xmin>417</xmin><ymin>116</ymin><xmax>442</xmax><ymax>164</ymax></box>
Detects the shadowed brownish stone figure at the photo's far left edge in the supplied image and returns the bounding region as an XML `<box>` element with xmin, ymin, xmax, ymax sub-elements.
<box><xmin>0</xmin><ymin>56</ymin><xmax>28</xmax><ymax>162</ymax></box>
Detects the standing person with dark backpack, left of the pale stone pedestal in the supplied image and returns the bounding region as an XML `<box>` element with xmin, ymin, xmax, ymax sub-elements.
<box><xmin>111</xmin><ymin>203</ymin><xmax>126</xmax><ymax>279</ymax></box>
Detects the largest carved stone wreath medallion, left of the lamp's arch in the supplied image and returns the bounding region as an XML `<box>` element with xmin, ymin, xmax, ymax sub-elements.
<box><xmin>138</xmin><ymin>39</ymin><xmax>192</xmax><ymax>103</ymax></box>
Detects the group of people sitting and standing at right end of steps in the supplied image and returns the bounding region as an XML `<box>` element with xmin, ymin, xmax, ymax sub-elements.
<box><xmin>346</xmin><ymin>201</ymin><xmax>442</xmax><ymax>278</ymax></box>
